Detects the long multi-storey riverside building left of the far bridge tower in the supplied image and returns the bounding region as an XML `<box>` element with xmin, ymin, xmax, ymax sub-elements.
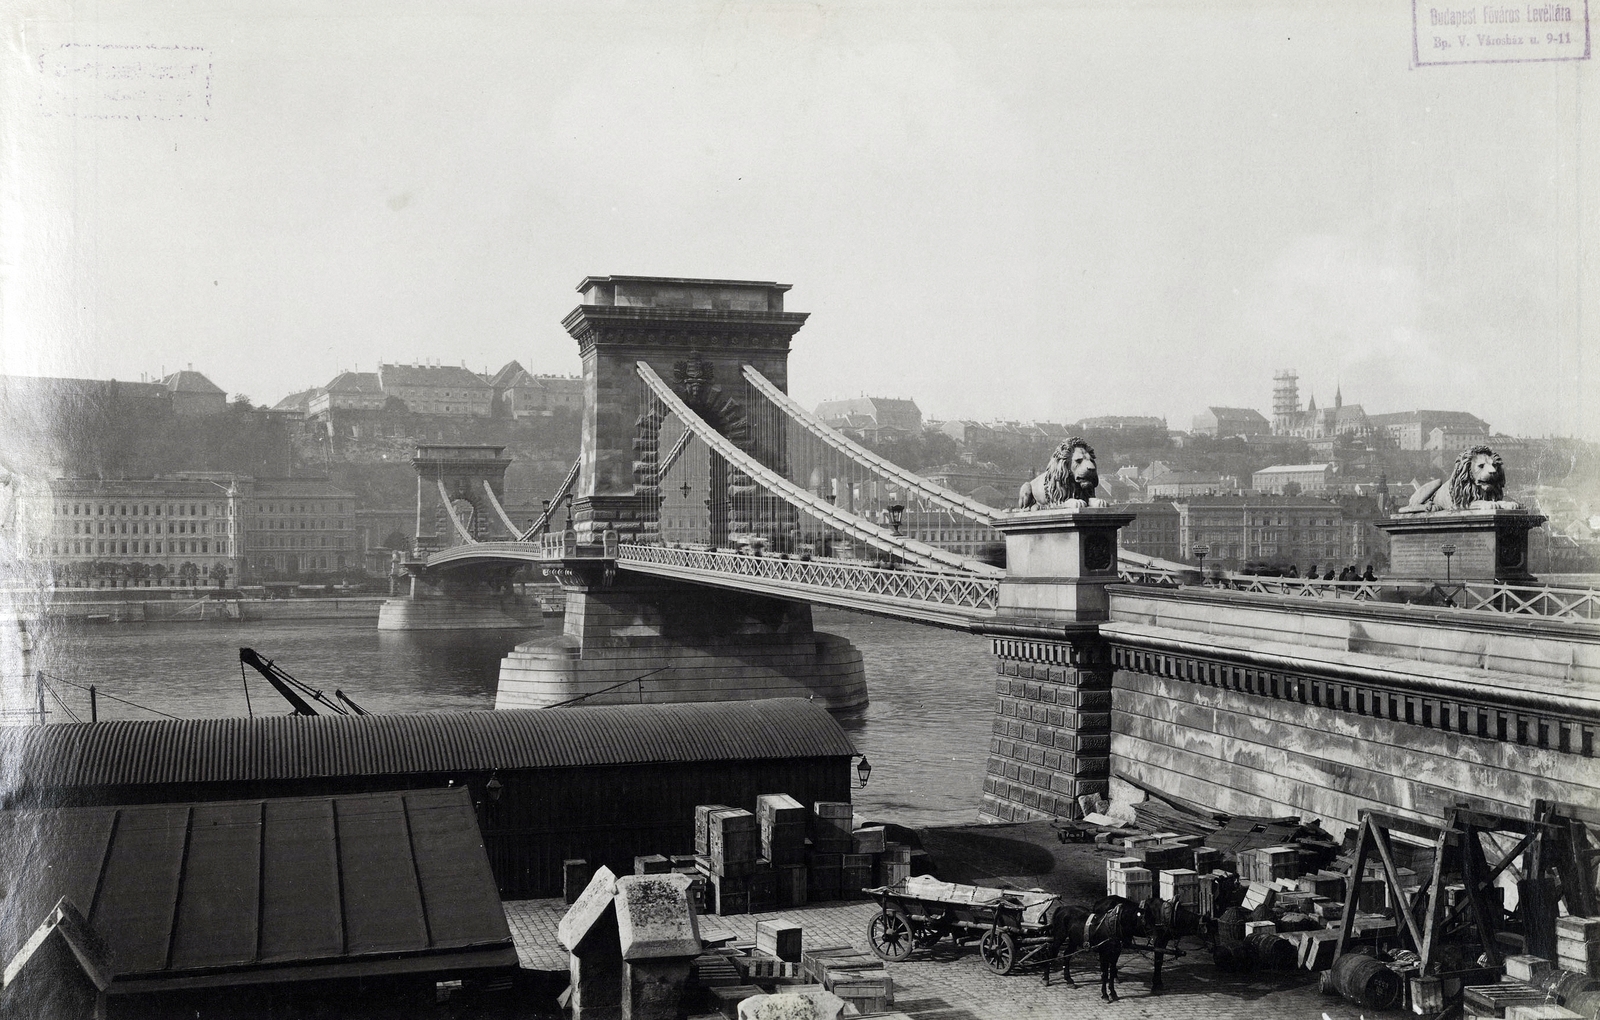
<box><xmin>21</xmin><ymin>472</ymin><xmax>360</xmax><ymax>587</ymax></box>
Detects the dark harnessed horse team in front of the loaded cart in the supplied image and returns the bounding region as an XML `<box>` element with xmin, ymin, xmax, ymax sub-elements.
<box><xmin>1045</xmin><ymin>895</ymin><xmax>1205</xmax><ymax>1002</ymax></box>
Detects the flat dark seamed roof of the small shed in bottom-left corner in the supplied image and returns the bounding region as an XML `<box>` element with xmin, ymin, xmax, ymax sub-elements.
<box><xmin>0</xmin><ymin>787</ymin><xmax>515</xmax><ymax>991</ymax></box>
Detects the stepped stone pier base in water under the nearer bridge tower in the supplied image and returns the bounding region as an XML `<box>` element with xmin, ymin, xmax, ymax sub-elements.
<box><xmin>494</xmin><ymin>576</ymin><xmax>867</xmax><ymax>710</ymax></box>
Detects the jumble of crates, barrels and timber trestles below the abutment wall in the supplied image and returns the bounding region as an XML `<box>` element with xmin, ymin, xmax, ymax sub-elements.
<box><xmin>1081</xmin><ymin>799</ymin><xmax>1600</xmax><ymax>1020</ymax></box>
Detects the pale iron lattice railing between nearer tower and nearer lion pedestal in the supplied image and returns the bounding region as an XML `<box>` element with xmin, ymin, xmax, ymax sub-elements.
<box><xmin>618</xmin><ymin>544</ymin><xmax>1000</xmax><ymax>609</ymax></box>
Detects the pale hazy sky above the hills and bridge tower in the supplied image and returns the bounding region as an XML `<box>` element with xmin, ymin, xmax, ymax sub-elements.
<box><xmin>0</xmin><ymin>0</ymin><xmax>1600</xmax><ymax>440</ymax></box>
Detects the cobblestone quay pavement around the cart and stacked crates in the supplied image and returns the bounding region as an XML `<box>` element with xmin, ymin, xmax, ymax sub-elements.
<box><xmin>506</xmin><ymin>900</ymin><xmax>1376</xmax><ymax>1020</ymax></box>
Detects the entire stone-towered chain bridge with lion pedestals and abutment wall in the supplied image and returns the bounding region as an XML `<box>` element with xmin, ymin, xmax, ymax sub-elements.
<box><xmin>381</xmin><ymin>277</ymin><xmax>1600</xmax><ymax>823</ymax></box>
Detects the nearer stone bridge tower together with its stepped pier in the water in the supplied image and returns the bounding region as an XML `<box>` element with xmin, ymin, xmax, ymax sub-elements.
<box><xmin>496</xmin><ymin>277</ymin><xmax>867</xmax><ymax>708</ymax></box>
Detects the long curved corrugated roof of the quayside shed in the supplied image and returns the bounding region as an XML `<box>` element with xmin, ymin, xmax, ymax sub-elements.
<box><xmin>0</xmin><ymin>699</ymin><xmax>854</xmax><ymax>790</ymax></box>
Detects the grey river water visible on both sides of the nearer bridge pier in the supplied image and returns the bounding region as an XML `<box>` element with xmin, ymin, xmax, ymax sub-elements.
<box><xmin>35</xmin><ymin>609</ymin><xmax>995</xmax><ymax>825</ymax></box>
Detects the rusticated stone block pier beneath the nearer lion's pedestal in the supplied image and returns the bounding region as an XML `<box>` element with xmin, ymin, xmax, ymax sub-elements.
<box><xmin>979</xmin><ymin>635</ymin><xmax>1112</xmax><ymax>822</ymax></box>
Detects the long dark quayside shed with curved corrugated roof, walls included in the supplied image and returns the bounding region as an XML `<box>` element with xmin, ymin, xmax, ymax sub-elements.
<box><xmin>0</xmin><ymin>699</ymin><xmax>854</xmax><ymax>898</ymax></box>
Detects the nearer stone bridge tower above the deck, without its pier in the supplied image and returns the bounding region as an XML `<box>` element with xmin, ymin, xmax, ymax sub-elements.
<box><xmin>562</xmin><ymin>277</ymin><xmax>808</xmax><ymax>544</ymax></box>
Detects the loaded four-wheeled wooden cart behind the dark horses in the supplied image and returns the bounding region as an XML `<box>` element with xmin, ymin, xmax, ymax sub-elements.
<box><xmin>864</xmin><ymin>875</ymin><xmax>1059</xmax><ymax>974</ymax></box>
